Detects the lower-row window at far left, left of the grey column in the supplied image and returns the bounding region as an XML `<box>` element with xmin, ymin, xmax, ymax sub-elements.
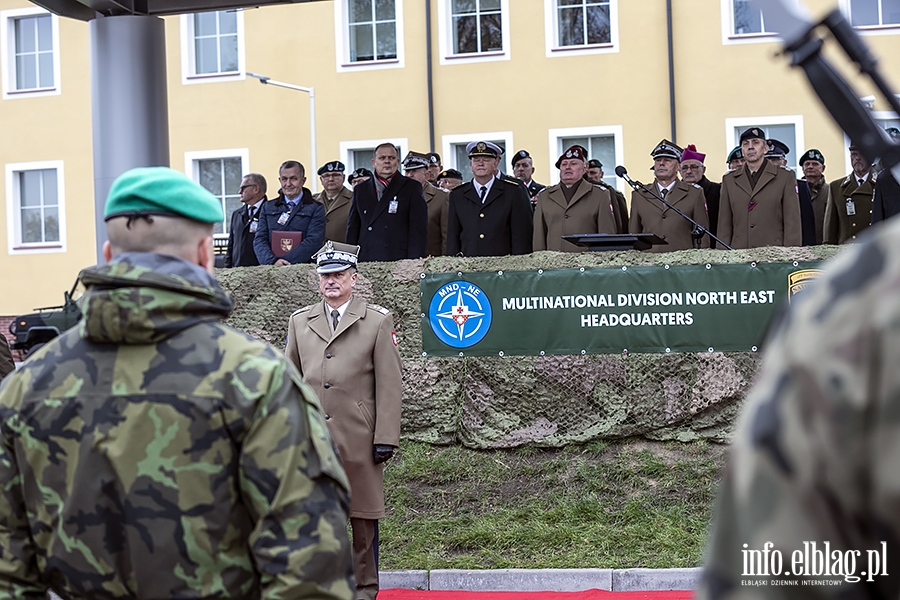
<box><xmin>6</xmin><ymin>161</ymin><xmax>65</xmax><ymax>252</ymax></box>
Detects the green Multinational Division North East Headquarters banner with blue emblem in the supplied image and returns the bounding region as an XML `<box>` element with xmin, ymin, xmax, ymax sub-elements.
<box><xmin>420</xmin><ymin>262</ymin><xmax>821</xmax><ymax>356</ymax></box>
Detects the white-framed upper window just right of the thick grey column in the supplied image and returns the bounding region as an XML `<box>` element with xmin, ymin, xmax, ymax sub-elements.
<box><xmin>182</xmin><ymin>10</ymin><xmax>244</xmax><ymax>80</ymax></box>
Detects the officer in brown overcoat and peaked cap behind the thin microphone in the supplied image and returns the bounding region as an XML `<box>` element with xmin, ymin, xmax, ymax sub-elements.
<box><xmin>628</xmin><ymin>140</ymin><xmax>710</xmax><ymax>252</ymax></box>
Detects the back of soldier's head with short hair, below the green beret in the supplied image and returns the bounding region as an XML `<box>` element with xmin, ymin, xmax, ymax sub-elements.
<box><xmin>103</xmin><ymin>215</ymin><xmax>215</xmax><ymax>273</ymax></box>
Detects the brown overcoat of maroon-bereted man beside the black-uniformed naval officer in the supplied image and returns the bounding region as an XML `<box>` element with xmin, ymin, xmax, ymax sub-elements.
<box><xmin>533</xmin><ymin>179</ymin><xmax>618</xmax><ymax>252</ymax></box>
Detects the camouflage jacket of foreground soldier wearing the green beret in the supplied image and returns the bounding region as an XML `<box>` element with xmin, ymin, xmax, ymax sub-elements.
<box><xmin>0</xmin><ymin>253</ymin><xmax>354</xmax><ymax>599</ymax></box>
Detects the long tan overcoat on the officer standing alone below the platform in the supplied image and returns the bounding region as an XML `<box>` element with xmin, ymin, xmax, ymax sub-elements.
<box><xmin>285</xmin><ymin>297</ymin><xmax>402</xmax><ymax>519</ymax></box>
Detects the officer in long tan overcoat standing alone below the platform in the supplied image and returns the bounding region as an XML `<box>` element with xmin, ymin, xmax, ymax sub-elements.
<box><xmin>285</xmin><ymin>242</ymin><xmax>402</xmax><ymax>600</ymax></box>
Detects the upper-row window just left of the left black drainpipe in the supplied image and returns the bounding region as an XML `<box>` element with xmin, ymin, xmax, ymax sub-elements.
<box><xmin>348</xmin><ymin>0</ymin><xmax>397</xmax><ymax>62</ymax></box>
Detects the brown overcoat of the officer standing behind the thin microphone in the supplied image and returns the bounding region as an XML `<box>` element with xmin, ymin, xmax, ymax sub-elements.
<box><xmin>628</xmin><ymin>180</ymin><xmax>710</xmax><ymax>252</ymax></box>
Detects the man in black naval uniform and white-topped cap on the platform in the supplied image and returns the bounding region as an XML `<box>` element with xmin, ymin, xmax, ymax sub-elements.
<box><xmin>447</xmin><ymin>141</ymin><xmax>533</xmax><ymax>256</ymax></box>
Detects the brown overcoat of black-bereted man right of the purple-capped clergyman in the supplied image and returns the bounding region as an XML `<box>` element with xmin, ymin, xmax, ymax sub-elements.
<box><xmin>716</xmin><ymin>161</ymin><xmax>803</xmax><ymax>248</ymax></box>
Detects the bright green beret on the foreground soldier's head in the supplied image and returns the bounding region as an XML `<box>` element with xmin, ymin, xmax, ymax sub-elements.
<box><xmin>103</xmin><ymin>167</ymin><xmax>225</xmax><ymax>223</ymax></box>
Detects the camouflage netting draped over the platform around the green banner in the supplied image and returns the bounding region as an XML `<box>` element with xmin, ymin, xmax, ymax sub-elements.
<box><xmin>216</xmin><ymin>246</ymin><xmax>839</xmax><ymax>448</ymax></box>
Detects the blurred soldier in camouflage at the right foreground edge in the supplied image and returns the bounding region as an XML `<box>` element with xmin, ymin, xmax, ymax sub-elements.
<box><xmin>697</xmin><ymin>214</ymin><xmax>900</xmax><ymax>599</ymax></box>
